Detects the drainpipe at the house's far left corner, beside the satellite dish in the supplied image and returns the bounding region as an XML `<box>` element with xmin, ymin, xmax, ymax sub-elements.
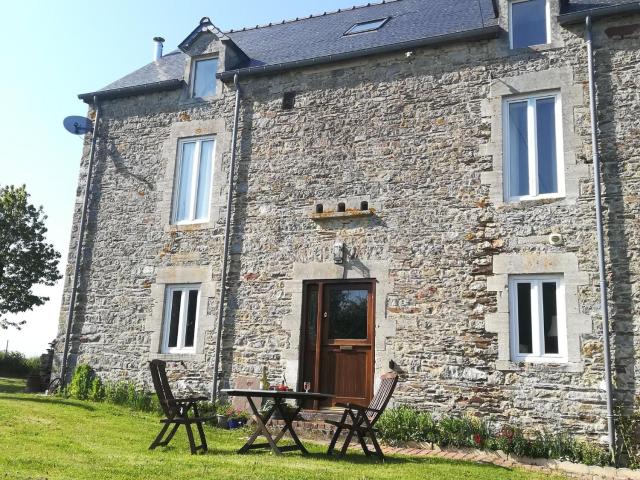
<box><xmin>60</xmin><ymin>95</ymin><xmax>100</xmax><ymax>387</ymax></box>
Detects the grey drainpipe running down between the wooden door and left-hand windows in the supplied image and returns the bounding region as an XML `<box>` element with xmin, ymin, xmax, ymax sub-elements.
<box><xmin>211</xmin><ymin>73</ymin><xmax>240</xmax><ymax>402</ymax></box>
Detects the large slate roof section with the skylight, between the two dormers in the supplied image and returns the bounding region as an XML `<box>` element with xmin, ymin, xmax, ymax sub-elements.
<box><xmin>227</xmin><ymin>0</ymin><xmax>497</xmax><ymax>67</ymax></box>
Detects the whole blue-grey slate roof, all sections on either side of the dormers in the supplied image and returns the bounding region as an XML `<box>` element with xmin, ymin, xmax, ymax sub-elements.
<box><xmin>80</xmin><ymin>0</ymin><xmax>639</xmax><ymax>100</ymax></box>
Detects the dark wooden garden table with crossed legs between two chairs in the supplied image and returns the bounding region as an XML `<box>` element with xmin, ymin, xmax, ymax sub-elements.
<box><xmin>222</xmin><ymin>388</ymin><xmax>333</xmax><ymax>455</ymax></box>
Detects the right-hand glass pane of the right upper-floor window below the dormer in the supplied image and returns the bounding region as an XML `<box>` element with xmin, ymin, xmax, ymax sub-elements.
<box><xmin>536</xmin><ymin>98</ymin><xmax>558</xmax><ymax>193</ymax></box>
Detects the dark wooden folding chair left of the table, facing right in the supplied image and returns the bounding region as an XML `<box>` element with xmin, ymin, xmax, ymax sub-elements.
<box><xmin>149</xmin><ymin>360</ymin><xmax>215</xmax><ymax>455</ymax></box>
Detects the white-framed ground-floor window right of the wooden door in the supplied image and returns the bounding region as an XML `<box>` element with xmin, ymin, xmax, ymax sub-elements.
<box><xmin>509</xmin><ymin>275</ymin><xmax>567</xmax><ymax>363</ymax></box>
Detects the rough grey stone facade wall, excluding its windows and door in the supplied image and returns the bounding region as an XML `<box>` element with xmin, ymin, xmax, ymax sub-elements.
<box><xmin>59</xmin><ymin>10</ymin><xmax>640</xmax><ymax>438</ymax></box>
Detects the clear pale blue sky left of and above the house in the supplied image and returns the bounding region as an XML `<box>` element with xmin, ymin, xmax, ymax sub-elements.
<box><xmin>0</xmin><ymin>0</ymin><xmax>366</xmax><ymax>355</ymax></box>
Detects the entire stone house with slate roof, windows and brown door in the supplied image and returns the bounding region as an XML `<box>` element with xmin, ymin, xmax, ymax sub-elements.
<box><xmin>57</xmin><ymin>0</ymin><xmax>640</xmax><ymax>438</ymax></box>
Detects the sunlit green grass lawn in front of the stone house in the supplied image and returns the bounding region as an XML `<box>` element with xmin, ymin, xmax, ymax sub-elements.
<box><xmin>0</xmin><ymin>379</ymin><xmax>564</xmax><ymax>480</ymax></box>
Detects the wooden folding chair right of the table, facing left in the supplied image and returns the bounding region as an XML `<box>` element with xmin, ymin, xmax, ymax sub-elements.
<box><xmin>325</xmin><ymin>372</ymin><xmax>398</xmax><ymax>460</ymax></box>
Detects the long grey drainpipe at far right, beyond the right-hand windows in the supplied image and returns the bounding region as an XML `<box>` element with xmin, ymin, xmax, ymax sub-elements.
<box><xmin>586</xmin><ymin>15</ymin><xmax>616</xmax><ymax>460</ymax></box>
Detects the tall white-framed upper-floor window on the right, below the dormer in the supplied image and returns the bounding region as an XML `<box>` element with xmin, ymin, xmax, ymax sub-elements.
<box><xmin>503</xmin><ymin>93</ymin><xmax>564</xmax><ymax>201</ymax></box>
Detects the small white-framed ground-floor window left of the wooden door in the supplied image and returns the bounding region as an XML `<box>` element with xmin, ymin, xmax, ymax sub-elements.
<box><xmin>162</xmin><ymin>285</ymin><xmax>200</xmax><ymax>353</ymax></box>
